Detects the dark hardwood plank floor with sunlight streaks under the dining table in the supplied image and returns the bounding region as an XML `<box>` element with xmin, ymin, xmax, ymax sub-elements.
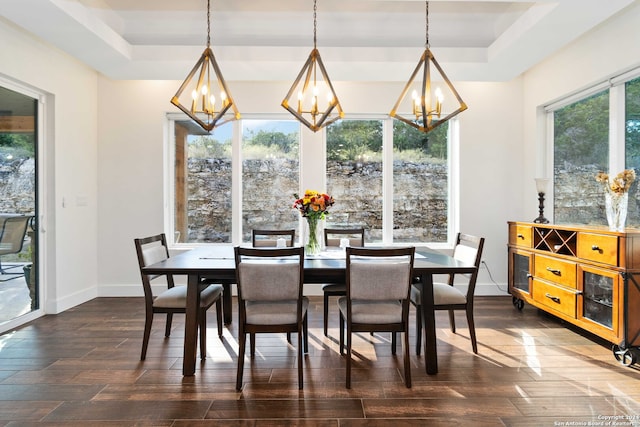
<box><xmin>0</xmin><ymin>297</ymin><xmax>640</xmax><ymax>426</ymax></box>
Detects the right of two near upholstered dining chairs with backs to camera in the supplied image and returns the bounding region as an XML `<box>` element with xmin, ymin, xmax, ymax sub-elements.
<box><xmin>338</xmin><ymin>247</ymin><xmax>415</xmax><ymax>388</ymax></box>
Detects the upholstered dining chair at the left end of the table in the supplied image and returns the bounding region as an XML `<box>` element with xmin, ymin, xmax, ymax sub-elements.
<box><xmin>134</xmin><ymin>233</ymin><xmax>222</xmax><ymax>360</ymax></box>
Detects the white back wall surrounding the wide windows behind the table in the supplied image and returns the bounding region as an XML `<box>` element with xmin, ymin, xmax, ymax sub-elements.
<box><xmin>98</xmin><ymin>77</ymin><xmax>524</xmax><ymax>295</ymax></box>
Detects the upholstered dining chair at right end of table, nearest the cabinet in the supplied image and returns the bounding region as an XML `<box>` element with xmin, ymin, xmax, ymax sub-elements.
<box><xmin>411</xmin><ymin>233</ymin><xmax>484</xmax><ymax>356</ymax></box>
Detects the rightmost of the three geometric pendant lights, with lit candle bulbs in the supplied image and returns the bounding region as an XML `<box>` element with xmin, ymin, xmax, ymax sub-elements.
<box><xmin>389</xmin><ymin>1</ymin><xmax>467</xmax><ymax>133</ymax></box>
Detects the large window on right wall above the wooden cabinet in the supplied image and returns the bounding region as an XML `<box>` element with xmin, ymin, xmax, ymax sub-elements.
<box><xmin>548</xmin><ymin>72</ymin><xmax>640</xmax><ymax>227</ymax></box>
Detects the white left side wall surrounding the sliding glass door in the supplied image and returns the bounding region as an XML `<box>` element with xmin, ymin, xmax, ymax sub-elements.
<box><xmin>0</xmin><ymin>19</ymin><xmax>98</xmax><ymax>313</ymax></box>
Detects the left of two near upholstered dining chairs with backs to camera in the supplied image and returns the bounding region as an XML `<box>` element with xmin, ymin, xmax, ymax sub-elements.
<box><xmin>235</xmin><ymin>246</ymin><xmax>309</xmax><ymax>391</ymax></box>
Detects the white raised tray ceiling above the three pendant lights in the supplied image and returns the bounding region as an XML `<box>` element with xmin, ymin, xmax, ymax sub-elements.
<box><xmin>0</xmin><ymin>0</ymin><xmax>634</xmax><ymax>81</ymax></box>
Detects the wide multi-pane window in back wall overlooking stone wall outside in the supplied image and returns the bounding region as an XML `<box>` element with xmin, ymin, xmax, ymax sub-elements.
<box><xmin>167</xmin><ymin>114</ymin><xmax>453</xmax><ymax>244</ymax></box>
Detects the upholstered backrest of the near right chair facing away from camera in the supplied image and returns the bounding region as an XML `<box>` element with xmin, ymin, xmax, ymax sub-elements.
<box><xmin>346</xmin><ymin>247</ymin><xmax>415</xmax><ymax>306</ymax></box>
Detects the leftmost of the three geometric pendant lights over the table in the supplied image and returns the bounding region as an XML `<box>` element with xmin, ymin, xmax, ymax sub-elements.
<box><xmin>171</xmin><ymin>0</ymin><xmax>240</xmax><ymax>132</ymax></box>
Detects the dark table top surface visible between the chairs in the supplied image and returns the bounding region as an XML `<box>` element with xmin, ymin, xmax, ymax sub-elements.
<box><xmin>143</xmin><ymin>245</ymin><xmax>475</xmax><ymax>274</ymax></box>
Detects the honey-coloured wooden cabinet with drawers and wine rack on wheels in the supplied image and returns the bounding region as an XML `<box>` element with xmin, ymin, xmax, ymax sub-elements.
<box><xmin>508</xmin><ymin>222</ymin><xmax>640</xmax><ymax>366</ymax></box>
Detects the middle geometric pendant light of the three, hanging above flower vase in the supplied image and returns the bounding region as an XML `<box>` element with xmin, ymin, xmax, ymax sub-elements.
<box><xmin>282</xmin><ymin>0</ymin><xmax>344</xmax><ymax>132</ymax></box>
